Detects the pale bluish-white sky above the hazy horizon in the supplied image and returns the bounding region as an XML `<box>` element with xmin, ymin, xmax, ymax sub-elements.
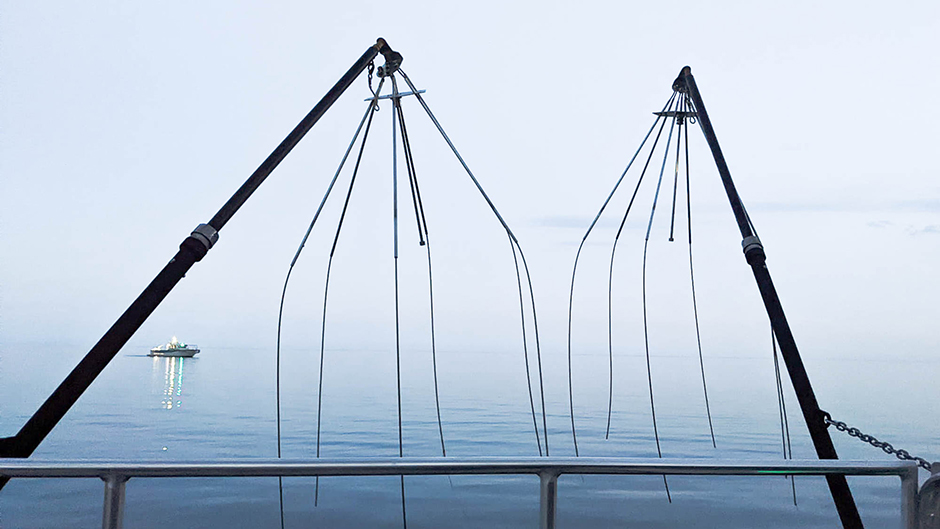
<box><xmin>0</xmin><ymin>1</ymin><xmax>940</xmax><ymax>362</ymax></box>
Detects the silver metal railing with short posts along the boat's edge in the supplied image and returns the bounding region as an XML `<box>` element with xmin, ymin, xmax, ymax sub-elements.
<box><xmin>0</xmin><ymin>457</ymin><xmax>917</xmax><ymax>529</ymax></box>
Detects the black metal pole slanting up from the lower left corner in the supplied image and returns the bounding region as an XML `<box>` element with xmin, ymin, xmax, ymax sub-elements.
<box><xmin>0</xmin><ymin>38</ymin><xmax>402</xmax><ymax>474</ymax></box>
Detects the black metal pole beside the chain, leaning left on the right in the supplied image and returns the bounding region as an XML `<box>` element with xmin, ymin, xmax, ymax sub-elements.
<box><xmin>672</xmin><ymin>66</ymin><xmax>862</xmax><ymax>528</ymax></box>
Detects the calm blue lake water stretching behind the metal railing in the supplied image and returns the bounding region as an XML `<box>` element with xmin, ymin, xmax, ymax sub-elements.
<box><xmin>0</xmin><ymin>343</ymin><xmax>940</xmax><ymax>529</ymax></box>
